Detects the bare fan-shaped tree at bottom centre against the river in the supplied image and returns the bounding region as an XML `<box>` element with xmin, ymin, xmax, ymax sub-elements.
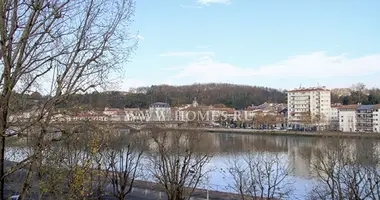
<box><xmin>148</xmin><ymin>129</ymin><xmax>212</xmax><ymax>200</ymax></box>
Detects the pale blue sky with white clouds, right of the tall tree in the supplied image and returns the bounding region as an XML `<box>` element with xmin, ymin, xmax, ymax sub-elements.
<box><xmin>118</xmin><ymin>0</ymin><xmax>380</xmax><ymax>90</ymax></box>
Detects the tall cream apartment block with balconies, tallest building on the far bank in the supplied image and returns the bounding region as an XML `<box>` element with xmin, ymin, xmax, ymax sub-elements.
<box><xmin>288</xmin><ymin>87</ymin><xmax>331</xmax><ymax>126</ymax></box>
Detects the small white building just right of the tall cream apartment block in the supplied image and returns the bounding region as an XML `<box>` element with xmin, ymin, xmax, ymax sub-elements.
<box><xmin>338</xmin><ymin>105</ymin><xmax>359</xmax><ymax>132</ymax></box>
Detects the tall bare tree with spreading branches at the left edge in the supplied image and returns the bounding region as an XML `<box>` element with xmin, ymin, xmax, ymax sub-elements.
<box><xmin>0</xmin><ymin>0</ymin><xmax>136</xmax><ymax>199</ymax></box>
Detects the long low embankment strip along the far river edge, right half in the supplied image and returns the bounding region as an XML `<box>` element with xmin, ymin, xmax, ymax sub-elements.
<box><xmin>167</xmin><ymin>127</ymin><xmax>380</xmax><ymax>139</ymax></box>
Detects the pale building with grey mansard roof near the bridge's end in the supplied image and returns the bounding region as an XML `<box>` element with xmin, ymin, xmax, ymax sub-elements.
<box><xmin>146</xmin><ymin>102</ymin><xmax>171</xmax><ymax>121</ymax></box>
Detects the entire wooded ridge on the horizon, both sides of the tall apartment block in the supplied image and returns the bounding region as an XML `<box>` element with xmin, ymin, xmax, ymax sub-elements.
<box><xmin>15</xmin><ymin>83</ymin><xmax>380</xmax><ymax>110</ymax></box>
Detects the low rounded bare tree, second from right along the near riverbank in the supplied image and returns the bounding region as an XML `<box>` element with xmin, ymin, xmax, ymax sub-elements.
<box><xmin>222</xmin><ymin>154</ymin><xmax>294</xmax><ymax>200</ymax></box>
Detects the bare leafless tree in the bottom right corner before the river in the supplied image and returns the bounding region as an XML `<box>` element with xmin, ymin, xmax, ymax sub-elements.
<box><xmin>309</xmin><ymin>138</ymin><xmax>380</xmax><ymax>200</ymax></box>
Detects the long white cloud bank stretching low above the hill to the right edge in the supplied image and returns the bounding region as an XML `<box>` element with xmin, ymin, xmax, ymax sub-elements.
<box><xmin>168</xmin><ymin>52</ymin><xmax>380</xmax><ymax>82</ymax></box>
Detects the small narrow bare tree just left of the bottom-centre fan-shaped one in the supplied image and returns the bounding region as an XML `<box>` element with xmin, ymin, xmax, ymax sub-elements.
<box><xmin>107</xmin><ymin>131</ymin><xmax>145</xmax><ymax>200</ymax></box>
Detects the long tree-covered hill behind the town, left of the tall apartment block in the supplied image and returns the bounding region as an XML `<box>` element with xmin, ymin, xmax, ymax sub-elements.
<box><xmin>62</xmin><ymin>83</ymin><xmax>286</xmax><ymax>109</ymax></box>
